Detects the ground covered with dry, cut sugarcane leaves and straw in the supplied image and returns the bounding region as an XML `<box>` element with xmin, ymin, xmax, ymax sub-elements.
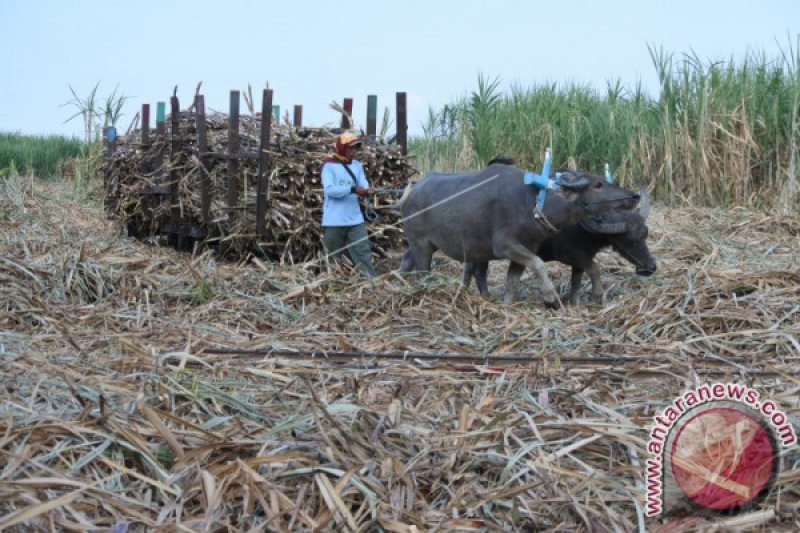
<box><xmin>0</xmin><ymin>179</ymin><xmax>800</xmax><ymax>532</ymax></box>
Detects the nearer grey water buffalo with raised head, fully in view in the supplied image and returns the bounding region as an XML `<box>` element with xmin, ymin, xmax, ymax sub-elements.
<box><xmin>397</xmin><ymin>163</ymin><xmax>639</xmax><ymax>307</ymax></box>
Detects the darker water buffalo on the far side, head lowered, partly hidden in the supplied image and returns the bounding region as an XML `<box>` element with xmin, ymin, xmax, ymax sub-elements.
<box><xmin>463</xmin><ymin>204</ymin><xmax>656</xmax><ymax>305</ymax></box>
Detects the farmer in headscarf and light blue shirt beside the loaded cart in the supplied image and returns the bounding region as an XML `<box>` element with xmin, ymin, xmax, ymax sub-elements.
<box><xmin>322</xmin><ymin>131</ymin><xmax>378</xmax><ymax>279</ymax></box>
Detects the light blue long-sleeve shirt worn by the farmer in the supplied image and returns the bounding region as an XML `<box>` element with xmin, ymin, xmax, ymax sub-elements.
<box><xmin>322</xmin><ymin>159</ymin><xmax>369</xmax><ymax>226</ymax></box>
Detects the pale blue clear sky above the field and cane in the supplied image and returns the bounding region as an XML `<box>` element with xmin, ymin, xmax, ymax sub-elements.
<box><xmin>0</xmin><ymin>0</ymin><xmax>800</xmax><ymax>136</ymax></box>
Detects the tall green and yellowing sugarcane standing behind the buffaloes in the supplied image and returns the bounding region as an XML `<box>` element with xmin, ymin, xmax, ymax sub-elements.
<box><xmin>410</xmin><ymin>37</ymin><xmax>800</xmax><ymax>212</ymax></box>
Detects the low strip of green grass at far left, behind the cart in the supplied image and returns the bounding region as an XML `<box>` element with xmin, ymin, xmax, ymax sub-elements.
<box><xmin>0</xmin><ymin>133</ymin><xmax>85</xmax><ymax>178</ymax></box>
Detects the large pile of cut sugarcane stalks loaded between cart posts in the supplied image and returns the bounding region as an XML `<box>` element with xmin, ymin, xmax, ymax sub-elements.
<box><xmin>104</xmin><ymin>112</ymin><xmax>416</xmax><ymax>262</ymax></box>
